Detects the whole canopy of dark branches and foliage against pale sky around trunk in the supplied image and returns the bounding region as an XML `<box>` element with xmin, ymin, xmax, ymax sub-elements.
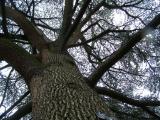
<box><xmin>0</xmin><ymin>0</ymin><xmax>160</xmax><ymax>120</ymax></box>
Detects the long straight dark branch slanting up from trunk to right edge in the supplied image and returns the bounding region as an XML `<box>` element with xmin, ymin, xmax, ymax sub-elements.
<box><xmin>89</xmin><ymin>14</ymin><xmax>160</xmax><ymax>87</ymax></box>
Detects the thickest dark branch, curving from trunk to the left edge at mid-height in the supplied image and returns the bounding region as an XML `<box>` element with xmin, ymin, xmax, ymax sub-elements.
<box><xmin>0</xmin><ymin>38</ymin><xmax>41</xmax><ymax>83</ymax></box>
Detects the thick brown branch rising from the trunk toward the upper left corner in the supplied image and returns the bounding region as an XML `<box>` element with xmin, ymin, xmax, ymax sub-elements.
<box><xmin>0</xmin><ymin>6</ymin><xmax>47</xmax><ymax>51</ymax></box>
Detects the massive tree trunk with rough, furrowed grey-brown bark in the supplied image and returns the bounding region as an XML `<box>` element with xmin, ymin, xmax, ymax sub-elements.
<box><xmin>30</xmin><ymin>50</ymin><xmax>115</xmax><ymax>120</ymax></box>
